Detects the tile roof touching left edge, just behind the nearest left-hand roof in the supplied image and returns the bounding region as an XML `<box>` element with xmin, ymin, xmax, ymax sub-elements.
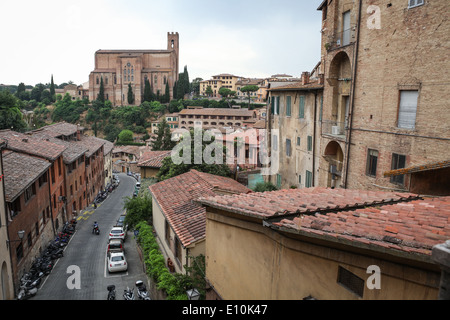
<box><xmin>0</xmin><ymin>130</ymin><xmax>66</xmax><ymax>161</ymax></box>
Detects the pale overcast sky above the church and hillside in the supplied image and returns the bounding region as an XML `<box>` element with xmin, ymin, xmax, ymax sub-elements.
<box><xmin>0</xmin><ymin>0</ymin><xmax>322</xmax><ymax>85</ymax></box>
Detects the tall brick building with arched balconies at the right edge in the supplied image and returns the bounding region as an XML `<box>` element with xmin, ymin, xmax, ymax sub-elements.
<box><xmin>318</xmin><ymin>0</ymin><xmax>450</xmax><ymax>195</ymax></box>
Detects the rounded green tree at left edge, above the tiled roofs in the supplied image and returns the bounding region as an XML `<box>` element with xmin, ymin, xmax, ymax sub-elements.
<box><xmin>0</xmin><ymin>90</ymin><xmax>27</xmax><ymax>131</ymax></box>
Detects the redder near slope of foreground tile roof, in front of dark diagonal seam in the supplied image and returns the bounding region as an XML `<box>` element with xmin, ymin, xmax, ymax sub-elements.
<box><xmin>275</xmin><ymin>197</ymin><xmax>450</xmax><ymax>256</ymax></box>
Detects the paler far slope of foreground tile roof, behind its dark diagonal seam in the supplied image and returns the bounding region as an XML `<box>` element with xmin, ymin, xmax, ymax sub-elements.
<box><xmin>198</xmin><ymin>187</ymin><xmax>417</xmax><ymax>219</ymax></box>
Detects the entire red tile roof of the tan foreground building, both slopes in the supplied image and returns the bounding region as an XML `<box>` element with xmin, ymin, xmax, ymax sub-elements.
<box><xmin>196</xmin><ymin>187</ymin><xmax>450</xmax><ymax>257</ymax></box>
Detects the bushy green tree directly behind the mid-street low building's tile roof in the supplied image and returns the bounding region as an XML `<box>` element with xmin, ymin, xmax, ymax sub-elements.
<box><xmin>157</xmin><ymin>129</ymin><xmax>231</xmax><ymax>181</ymax></box>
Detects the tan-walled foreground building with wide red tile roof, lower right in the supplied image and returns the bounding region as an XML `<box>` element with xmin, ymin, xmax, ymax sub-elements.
<box><xmin>200</xmin><ymin>187</ymin><xmax>450</xmax><ymax>301</ymax></box>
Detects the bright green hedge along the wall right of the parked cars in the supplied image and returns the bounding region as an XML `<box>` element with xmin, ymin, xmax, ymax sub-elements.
<box><xmin>135</xmin><ymin>221</ymin><xmax>188</xmax><ymax>300</ymax></box>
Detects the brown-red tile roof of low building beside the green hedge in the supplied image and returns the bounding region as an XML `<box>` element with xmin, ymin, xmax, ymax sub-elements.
<box><xmin>149</xmin><ymin>170</ymin><xmax>250</xmax><ymax>247</ymax></box>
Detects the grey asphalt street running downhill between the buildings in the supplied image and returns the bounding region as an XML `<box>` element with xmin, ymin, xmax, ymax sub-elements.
<box><xmin>31</xmin><ymin>174</ymin><xmax>148</xmax><ymax>300</ymax></box>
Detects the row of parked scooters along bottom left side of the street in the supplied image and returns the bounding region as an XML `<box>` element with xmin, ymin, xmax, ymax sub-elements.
<box><xmin>17</xmin><ymin>219</ymin><xmax>77</xmax><ymax>300</ymax></box>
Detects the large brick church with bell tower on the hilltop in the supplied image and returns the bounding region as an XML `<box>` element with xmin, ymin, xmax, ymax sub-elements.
<box><xmin>89</xmin><ymin>32</ymin><xmax>179</xmax><ymax>106</ymax></box>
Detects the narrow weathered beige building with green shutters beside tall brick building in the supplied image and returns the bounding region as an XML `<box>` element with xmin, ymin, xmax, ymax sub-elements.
<box><xmin>266</xmin><ymin>72</ymin><xmax>323</xmax><ymax>188</ymax></box>
